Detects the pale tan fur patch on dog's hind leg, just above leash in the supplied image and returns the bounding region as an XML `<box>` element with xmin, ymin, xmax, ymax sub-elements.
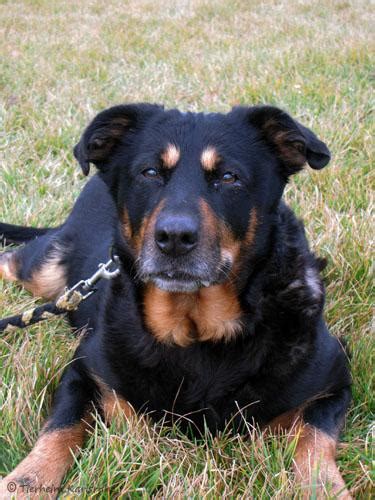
<box><xmin>22</xmin><ymin>245</ymin><xmax>67</xmax><ymax>300</ymax></box>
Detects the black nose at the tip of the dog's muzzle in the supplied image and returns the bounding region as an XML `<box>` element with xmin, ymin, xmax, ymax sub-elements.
<box><xmin>155</xmin><ymin>214</ymin><xmax>198</xmax><ymax>257</ymax></box>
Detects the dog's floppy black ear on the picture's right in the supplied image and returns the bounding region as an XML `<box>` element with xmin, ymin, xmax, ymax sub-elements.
<box><xmin>248</xmin><ymin>106</ymin><xmax>331</xmax><ymax>175</ymax></box>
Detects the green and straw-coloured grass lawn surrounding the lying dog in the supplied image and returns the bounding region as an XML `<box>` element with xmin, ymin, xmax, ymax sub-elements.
<box><xmin>0</xmin><ymin>0</ymin><xmax>375</xmax><ymax>499</ymax></box>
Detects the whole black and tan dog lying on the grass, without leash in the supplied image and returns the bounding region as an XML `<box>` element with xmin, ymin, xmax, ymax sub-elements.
<box><xmin>0</xmin><ymin>104</ymin><xmax>351</xmax><ymax>498</ymax></box>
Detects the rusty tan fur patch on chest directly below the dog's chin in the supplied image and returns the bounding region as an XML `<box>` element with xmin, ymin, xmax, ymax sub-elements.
<box><xmin>144</xmin><ymin>284</ymin><xmax>242</xmax><ymax>346</ymax></box>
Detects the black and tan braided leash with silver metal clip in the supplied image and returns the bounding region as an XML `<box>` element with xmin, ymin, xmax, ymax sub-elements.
<box><xmin>0</xmin><ymin>255</ymin><xmax>120</xmax><ymax>333</ymax></box>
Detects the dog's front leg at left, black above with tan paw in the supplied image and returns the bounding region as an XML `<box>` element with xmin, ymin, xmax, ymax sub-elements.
<box><xmin>0</xmin><ymin>362</ymin><xmax>94</xmax><ymax>498</ymax></box>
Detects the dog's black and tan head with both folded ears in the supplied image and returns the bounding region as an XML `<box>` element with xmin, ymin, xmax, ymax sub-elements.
<box><xmin>74</xmin><ymin>104</ymin><xmax>330</xmax><ymax>292</ymax></box>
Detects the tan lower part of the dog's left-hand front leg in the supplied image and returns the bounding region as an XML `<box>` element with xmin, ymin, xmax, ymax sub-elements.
<box><xmin>0</xmin><ymin>422</ymin><xmax>87</xmax><ymax>498</ymax></box>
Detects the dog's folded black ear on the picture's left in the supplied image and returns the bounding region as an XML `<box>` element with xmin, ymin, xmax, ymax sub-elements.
<box><xmin>73</xmin><ymin>103</ymin><xmax>163</xmax><ymax>175</ymax></box>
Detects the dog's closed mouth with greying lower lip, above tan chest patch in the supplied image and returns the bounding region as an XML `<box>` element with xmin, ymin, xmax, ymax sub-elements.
<box><xmin>142</xmin><ymin>271</ymin><xmax>215</xmax><ymax>293</ymax></box>
